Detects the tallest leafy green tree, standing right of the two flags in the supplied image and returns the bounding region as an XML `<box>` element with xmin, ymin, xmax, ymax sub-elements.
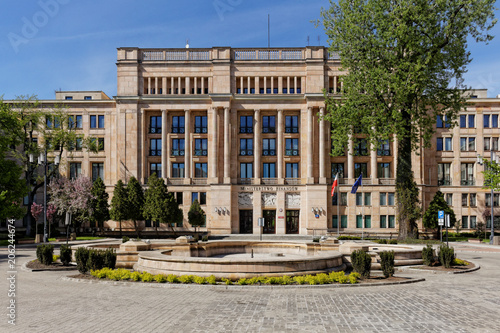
<box><xmin>322</xmin><ymin>0</ymin><xmax>496</xmax><ymax>238</ymax></box>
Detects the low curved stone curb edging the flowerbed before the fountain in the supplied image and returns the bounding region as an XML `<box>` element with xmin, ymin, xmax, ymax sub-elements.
<box><xmin>61</xmin><ymin>276</ymin><xmax>425</xmax><ymax>290</ymax></box>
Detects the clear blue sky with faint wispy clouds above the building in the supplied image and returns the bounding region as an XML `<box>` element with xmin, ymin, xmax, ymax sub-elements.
<box><xmin>0</xmin><ymin>0</ymin><xmax>500</xmax><ymax>99</ymax></box>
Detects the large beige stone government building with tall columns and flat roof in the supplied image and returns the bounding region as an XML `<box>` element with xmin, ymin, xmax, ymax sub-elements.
<box><xmin>9</xmin><ymin>47</ymin><xmax>500</xmax><ymax>237</ymax></box>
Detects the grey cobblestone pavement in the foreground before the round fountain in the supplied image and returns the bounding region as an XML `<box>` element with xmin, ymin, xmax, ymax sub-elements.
<box><xmin>0</xmin><ymin>246</ymin><xmax>500</xmax><ymax>332</ymax></box>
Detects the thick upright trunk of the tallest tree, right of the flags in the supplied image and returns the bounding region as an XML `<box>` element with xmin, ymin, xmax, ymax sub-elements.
<box><xmin>396</xmin><ymin>111</ymin><xmax>420</xmax><ymax>239</ymax></box>
